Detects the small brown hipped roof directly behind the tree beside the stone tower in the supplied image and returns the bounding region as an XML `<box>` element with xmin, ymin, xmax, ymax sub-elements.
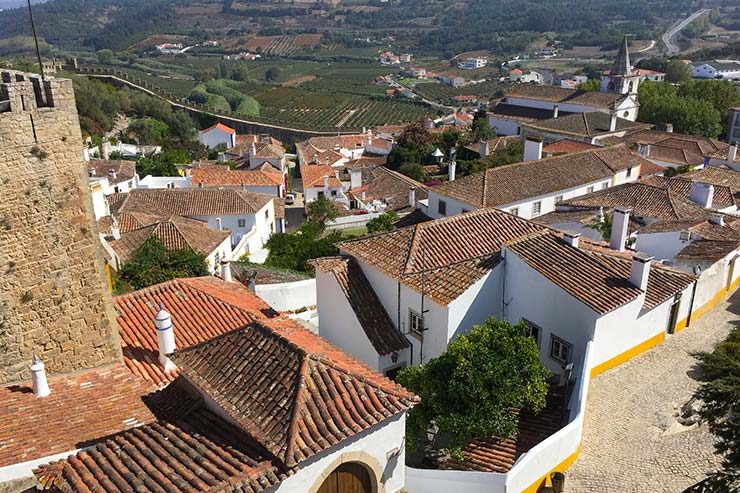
<box><xmin>108</xmin><ymin>216</ymin><xmax>231</xmax><ymax>262</ymax></box>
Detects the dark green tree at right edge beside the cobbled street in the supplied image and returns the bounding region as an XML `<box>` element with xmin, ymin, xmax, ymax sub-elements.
<box><xmin>695</xmin><ymin>327</ymin><xmax>740</xmax><ymax>491</ymax></box>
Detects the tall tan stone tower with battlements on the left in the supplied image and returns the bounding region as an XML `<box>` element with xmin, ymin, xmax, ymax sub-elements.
<box><xmin>0</xmin><ymin>71</ymin><xmax>121</xmax><ymax>383</ymax></box>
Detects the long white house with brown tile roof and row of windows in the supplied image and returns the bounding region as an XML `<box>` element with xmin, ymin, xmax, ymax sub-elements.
<box><xmin>426</xmin><ymin>142</ymin><xmax>644</xmax><ymax>219</ymax></box>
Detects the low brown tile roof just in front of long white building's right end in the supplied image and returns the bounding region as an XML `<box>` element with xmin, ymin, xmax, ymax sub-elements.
<box><xmin>561</xmin><ymin>182</ymin><xmax>707</xmax><ymax>220</ymax></box>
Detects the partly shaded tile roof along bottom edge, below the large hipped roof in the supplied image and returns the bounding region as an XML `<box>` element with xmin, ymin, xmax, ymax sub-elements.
<box><xmin>34</xmin><ymin>381</ymin><xmax>289</xmax><ymax>493</ymax></box>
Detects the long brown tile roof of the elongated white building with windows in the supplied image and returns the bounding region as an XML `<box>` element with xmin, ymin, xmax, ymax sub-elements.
<box><xmin>431</xmin><ymin>146</ymin><xmax>644</xmax><ymax>207</ymax></box>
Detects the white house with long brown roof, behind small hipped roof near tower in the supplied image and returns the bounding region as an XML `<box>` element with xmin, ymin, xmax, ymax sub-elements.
<box><xmin>118</xmin><ymin>188</ymin><xmax>284</xmax><ymax>258</ymax></box>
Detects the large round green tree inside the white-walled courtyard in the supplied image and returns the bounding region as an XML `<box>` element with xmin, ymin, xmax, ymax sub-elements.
<box><xmin>398</xmin><ymin>318</ymin><xmax>550</xmax><ymax>457</ymax></box>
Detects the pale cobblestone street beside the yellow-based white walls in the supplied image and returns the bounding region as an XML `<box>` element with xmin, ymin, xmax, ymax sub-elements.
<box><xmin>566</xmin><ymin>292</ymin><xmax>740</xmax><ymax>493</ymax></box>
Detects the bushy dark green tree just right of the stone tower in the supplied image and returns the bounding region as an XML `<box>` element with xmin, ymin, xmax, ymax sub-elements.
<box><xmin>118</xmin><ymin>236</ymin><xmax>208</xmax><ymax>289</ymax></box>
